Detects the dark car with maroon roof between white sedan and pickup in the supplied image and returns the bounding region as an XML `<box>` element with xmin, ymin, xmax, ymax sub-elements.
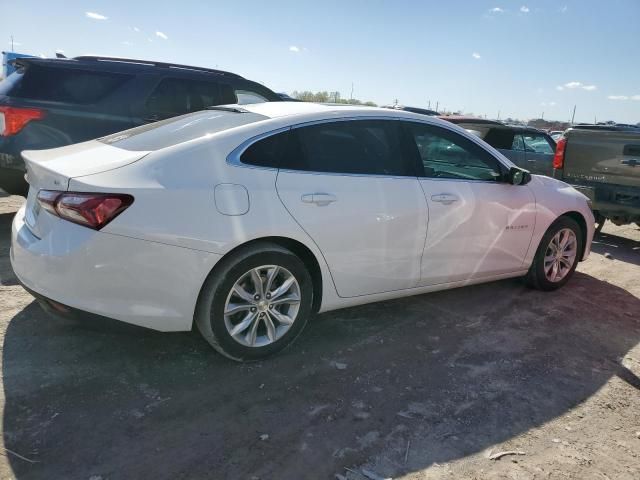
<box><xmin>440</xmin><ymin>115</ymin><xmax>556</xmax><ymax>176</ymax></box>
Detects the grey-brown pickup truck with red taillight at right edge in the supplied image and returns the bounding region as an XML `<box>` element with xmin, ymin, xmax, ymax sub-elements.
<box><xmin>553</xmin><ymin>125</ymin><xmax>640</xmax><ymax>231</ymax></box>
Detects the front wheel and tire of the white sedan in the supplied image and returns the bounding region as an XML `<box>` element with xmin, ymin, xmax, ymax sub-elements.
<box><xmin>525</xmin><ymin>217</ymin><xmax>582</xmax><ymax>291</ymax></box>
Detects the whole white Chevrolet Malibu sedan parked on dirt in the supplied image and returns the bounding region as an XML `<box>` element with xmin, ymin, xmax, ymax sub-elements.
<box><xmin>11</xmin><ymin>102</ymin><xmax>594</xmax><ymax>360</ymax></box>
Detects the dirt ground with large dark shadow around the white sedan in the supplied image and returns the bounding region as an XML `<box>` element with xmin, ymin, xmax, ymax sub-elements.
<box><xmin>0</xmin><ymin>197</ymin><xmax>640</xmax><ymax>480</ymax></box>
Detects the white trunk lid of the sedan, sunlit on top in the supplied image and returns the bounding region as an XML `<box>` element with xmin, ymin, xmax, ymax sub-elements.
<box><xmin>22</xmin><ymin>140</ymin><xmax>149</xmax><ymax>238</ymax></box>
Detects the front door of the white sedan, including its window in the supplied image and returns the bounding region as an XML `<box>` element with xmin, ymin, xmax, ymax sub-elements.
<box><xmin>405</xmin><ymin>122</ymin><xmax>536</xmax><ymax>285</ymax></box>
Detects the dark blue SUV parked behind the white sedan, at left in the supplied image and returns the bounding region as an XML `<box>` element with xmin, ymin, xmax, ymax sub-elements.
<box><xmin>0</xmin><ymin>56</ymin><xmax>280</xmax><ymax>195</ymax></box>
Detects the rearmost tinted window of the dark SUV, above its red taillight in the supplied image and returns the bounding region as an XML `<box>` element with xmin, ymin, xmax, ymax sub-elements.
<box><xmin>0</xmin><ymin>64</ymin><xmax>132</xmax><ymax>104</ymax></box>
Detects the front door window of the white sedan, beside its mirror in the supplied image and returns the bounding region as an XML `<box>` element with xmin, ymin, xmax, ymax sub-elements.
<box><xmin>407</xmin><ymin>123</ymin><xmax>502</xmax><ymax>181</ymax></box>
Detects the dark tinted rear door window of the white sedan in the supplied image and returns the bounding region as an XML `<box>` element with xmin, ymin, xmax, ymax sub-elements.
<box><xmin>280</xmin><ymin>120</ymin><xmax>412</xmax><ymax>176</ymax></box>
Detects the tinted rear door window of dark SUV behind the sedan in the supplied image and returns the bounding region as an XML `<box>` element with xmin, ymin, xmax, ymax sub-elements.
<box><xmin>146</xmin><ymin>78</ymin><xmax>236</xmax><ymax>118</ymax></box>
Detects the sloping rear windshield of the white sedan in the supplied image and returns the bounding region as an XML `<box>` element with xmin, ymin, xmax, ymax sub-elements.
<box><xmin>98</xmin><ymin>110</ymin><xmax>269</xmax><ymax>151</ymax></box>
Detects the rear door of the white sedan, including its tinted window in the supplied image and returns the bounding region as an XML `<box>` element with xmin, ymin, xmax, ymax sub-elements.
<box><xmin>276</xmin><ymin>119</ymin><xmax>427</xmax><ymax>297</ymax></box>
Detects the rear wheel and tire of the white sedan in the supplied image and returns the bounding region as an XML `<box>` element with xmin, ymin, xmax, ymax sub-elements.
<box><xmin>195</xmin><ymin>242</ymin><xmax>313</xmax><ymax>361</ymax></box>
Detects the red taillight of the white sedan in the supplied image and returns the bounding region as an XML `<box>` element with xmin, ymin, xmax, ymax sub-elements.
<box><xmin>37</xmin><ymin>190</ymin><xmax>133</xmax><ymax>230</ymax></box>
